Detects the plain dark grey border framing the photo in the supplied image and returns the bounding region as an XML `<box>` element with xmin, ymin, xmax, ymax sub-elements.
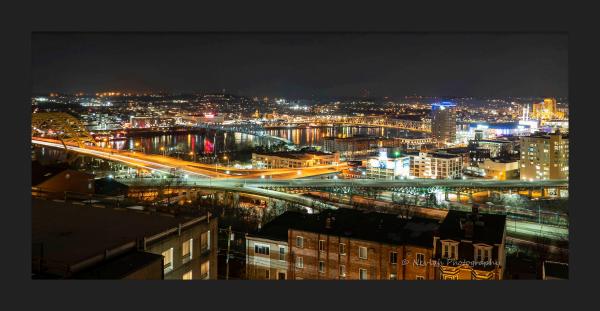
<box><xmin>0</xmin><ymin>0</ymin><xmax>600</xmax><ymax>310</ymax></box>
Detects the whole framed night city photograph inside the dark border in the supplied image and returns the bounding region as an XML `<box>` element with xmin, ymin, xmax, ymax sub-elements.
<box><xmin>31</xmin><ymin>33</ymin><xmax>570</xmax><ymax>281</ymax></box>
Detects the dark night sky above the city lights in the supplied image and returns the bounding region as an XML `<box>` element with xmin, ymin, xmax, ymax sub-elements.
<box><xmin>32</xmin><ymin>33</ymin><xmax>568</xmax><ymax>98</ymax></box>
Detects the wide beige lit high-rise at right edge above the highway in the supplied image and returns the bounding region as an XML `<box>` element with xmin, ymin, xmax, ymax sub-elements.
<box><xmin>519</xmin><ymin>132</ymin><xmax>569</xmax><ymax>180</ymax></box>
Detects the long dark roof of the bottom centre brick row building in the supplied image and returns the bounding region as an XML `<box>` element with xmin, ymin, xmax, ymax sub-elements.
<box><xmin>250</xmin><ymin>208</ymin><xmax>439</xmax><ymax>250</ymax></box>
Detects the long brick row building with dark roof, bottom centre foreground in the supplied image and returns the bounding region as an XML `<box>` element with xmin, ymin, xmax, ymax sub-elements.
<box><xmin>247</xmin><ymin>209</ymin><xmax>438</xmax><ymax>280</ymax></box>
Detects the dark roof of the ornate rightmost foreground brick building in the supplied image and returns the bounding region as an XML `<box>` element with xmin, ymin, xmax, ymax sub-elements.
<box><xmin>438</xmin><ymin>210</ymin><xmax>506</xmax><ymax>245</ymax></box>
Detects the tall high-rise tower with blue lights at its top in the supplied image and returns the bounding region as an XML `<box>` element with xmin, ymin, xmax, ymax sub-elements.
<box><xmin>431</xmin><ymin>102</ymin><xmax>456</xmax><ymax>145</ymax></box>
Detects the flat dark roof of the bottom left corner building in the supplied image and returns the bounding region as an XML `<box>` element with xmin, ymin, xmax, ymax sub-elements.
<box><xmin>31</xmin><ymin>199</ymin><xmax>206</xmax><ymax>272</ymax></box>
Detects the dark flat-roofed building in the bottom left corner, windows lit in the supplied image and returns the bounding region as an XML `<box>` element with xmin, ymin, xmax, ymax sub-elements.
<box><xmin>32</xmin><ymin>198</ymin><xmax>217</xmax><ymax>280</ymax></box>
